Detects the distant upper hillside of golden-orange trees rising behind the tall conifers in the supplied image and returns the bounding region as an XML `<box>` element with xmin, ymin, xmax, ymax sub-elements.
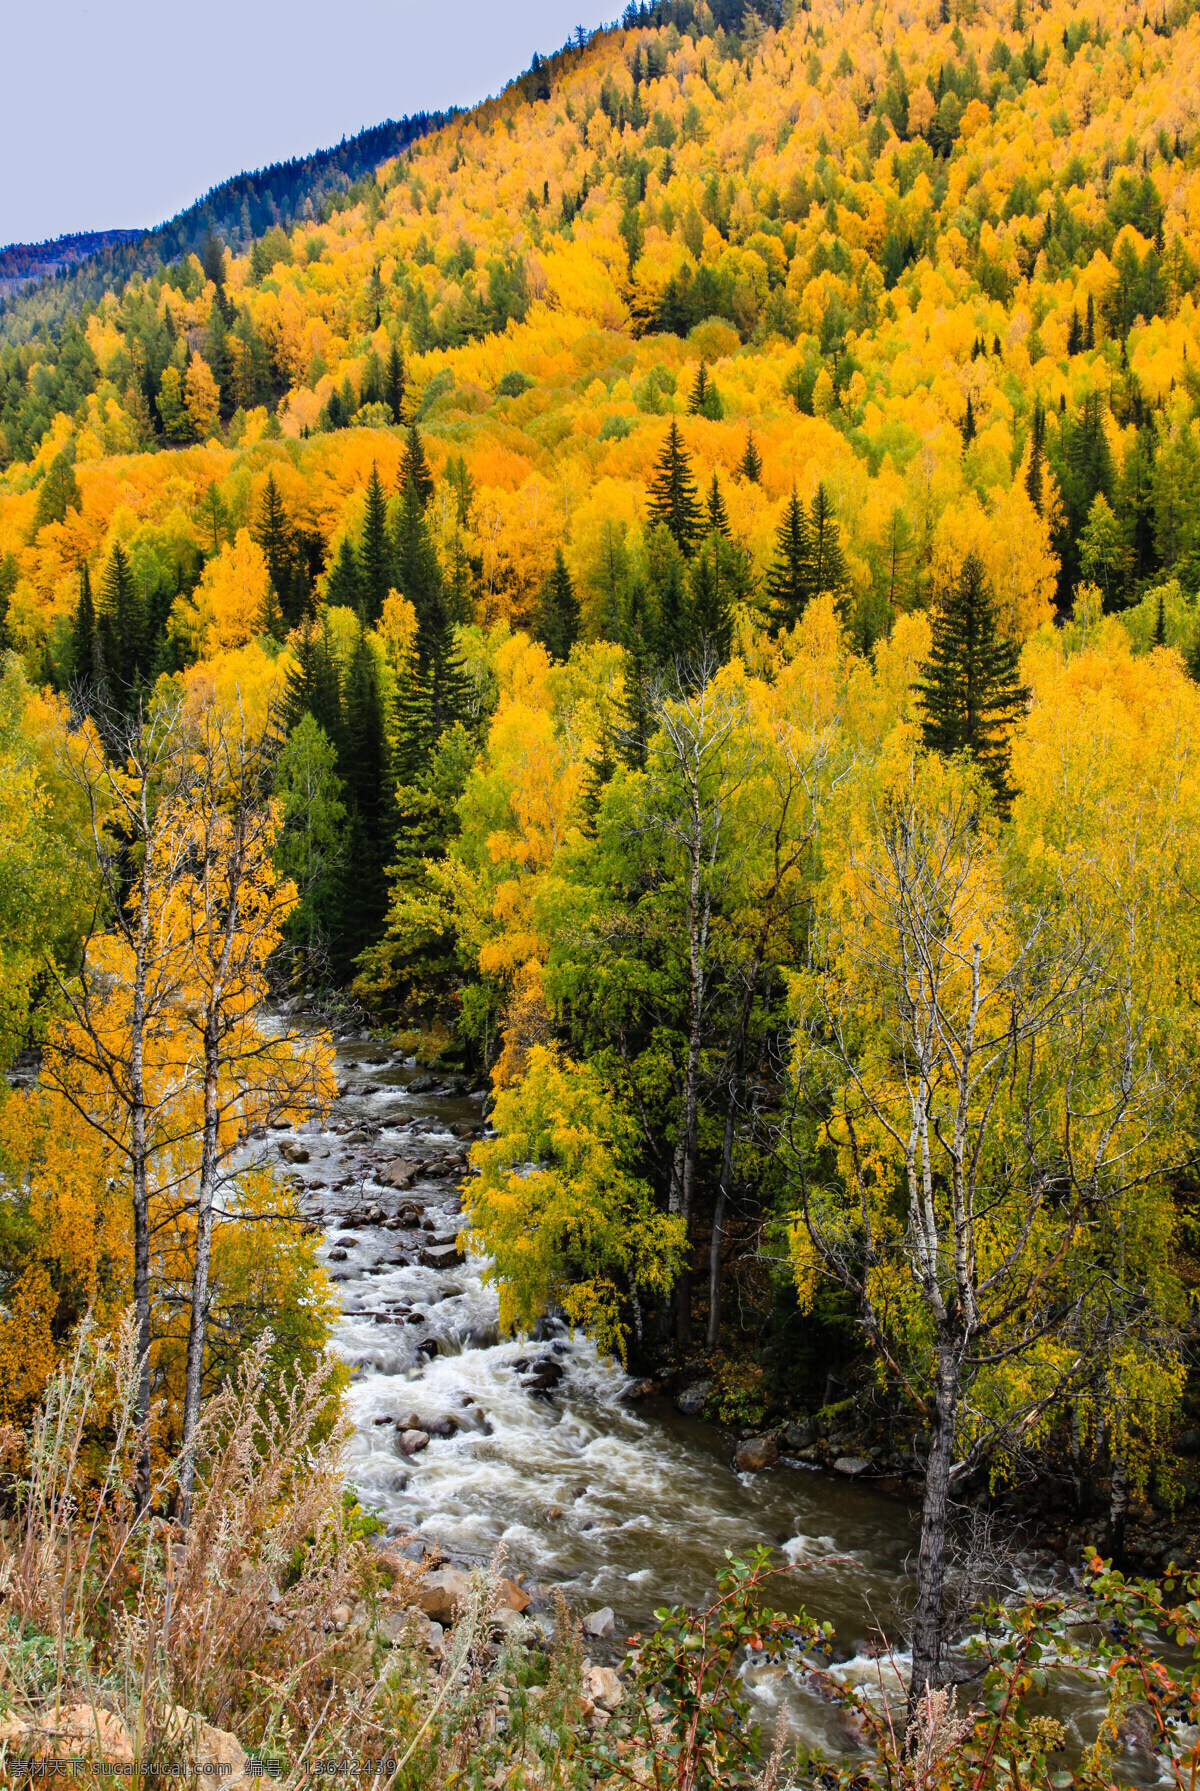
<box><xmin>0</xmin><ymin>0</ymin><xmax>1200</xmax><ymax>656</ymax></box>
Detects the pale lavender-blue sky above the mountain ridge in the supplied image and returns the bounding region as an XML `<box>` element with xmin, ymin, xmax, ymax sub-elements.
<box><xmin>0</xmin><ymin>0</ymin><xmax>621</xmax><ymax>244</ymax></box>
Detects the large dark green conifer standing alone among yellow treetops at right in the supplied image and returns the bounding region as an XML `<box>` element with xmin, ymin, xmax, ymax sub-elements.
<box><xmin>915</xmin><ymin>553</ymin><xmax>1028</xmax><ymax>815</ymax></box>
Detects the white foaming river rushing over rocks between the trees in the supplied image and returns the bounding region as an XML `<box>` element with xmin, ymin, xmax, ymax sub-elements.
<box><xmin>276</xmin><ymin>1042</ymin><xmax>1110</xmax><ymax>1752</ymax></box>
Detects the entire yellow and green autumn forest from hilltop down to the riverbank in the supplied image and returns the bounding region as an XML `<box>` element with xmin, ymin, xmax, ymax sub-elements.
<box><xmin>0</xmin><ymin>0</ymin><xmax>1200</xmax><ymax>1755</ymax></box>
